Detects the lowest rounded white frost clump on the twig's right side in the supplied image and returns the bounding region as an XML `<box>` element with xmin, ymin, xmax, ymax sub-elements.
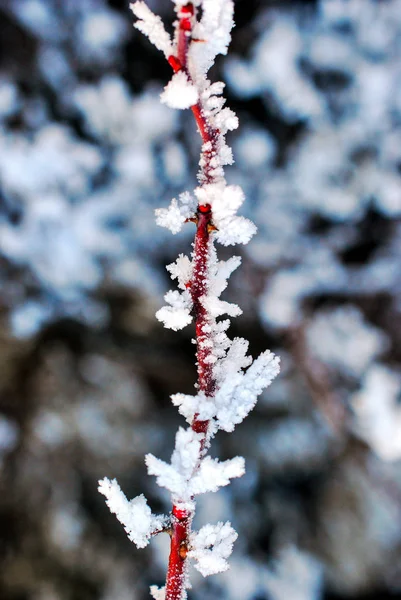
<box><xmin>188</xmin><ymin>521</ymin><xmax>238</xmax><ymax>577</ymax></box>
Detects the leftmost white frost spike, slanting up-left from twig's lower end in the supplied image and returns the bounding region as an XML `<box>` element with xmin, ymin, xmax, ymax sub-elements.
<box><xmin>99</xmin><ymin>477</ymin><xmax>167</xmax><ymax>548</ymax></box>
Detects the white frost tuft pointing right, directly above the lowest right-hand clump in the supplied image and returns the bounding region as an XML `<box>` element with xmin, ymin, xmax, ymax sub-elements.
<box><xmin>190</xmin><ymin>456</ymin><xmax>245</xmax><ymax>495</ymax></box>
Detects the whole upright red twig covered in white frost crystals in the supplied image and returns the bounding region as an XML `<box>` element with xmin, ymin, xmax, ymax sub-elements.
<box><xmin>99</xmin><ymin>0</ymin><xmax>279</xmax><ymax>600</ymax></box>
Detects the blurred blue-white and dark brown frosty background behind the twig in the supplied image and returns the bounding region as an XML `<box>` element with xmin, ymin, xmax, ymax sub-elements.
<box><xmin>0</xmin><ymin>0</ymin><xmax>401</xmax><ymax>600</ymax></box>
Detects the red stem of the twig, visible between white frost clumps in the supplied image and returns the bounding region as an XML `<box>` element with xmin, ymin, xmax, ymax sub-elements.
<box><xmin>166</xmin><ymin>2</ymin><xmax>219</xmax><ymax>600</ymax></box>
